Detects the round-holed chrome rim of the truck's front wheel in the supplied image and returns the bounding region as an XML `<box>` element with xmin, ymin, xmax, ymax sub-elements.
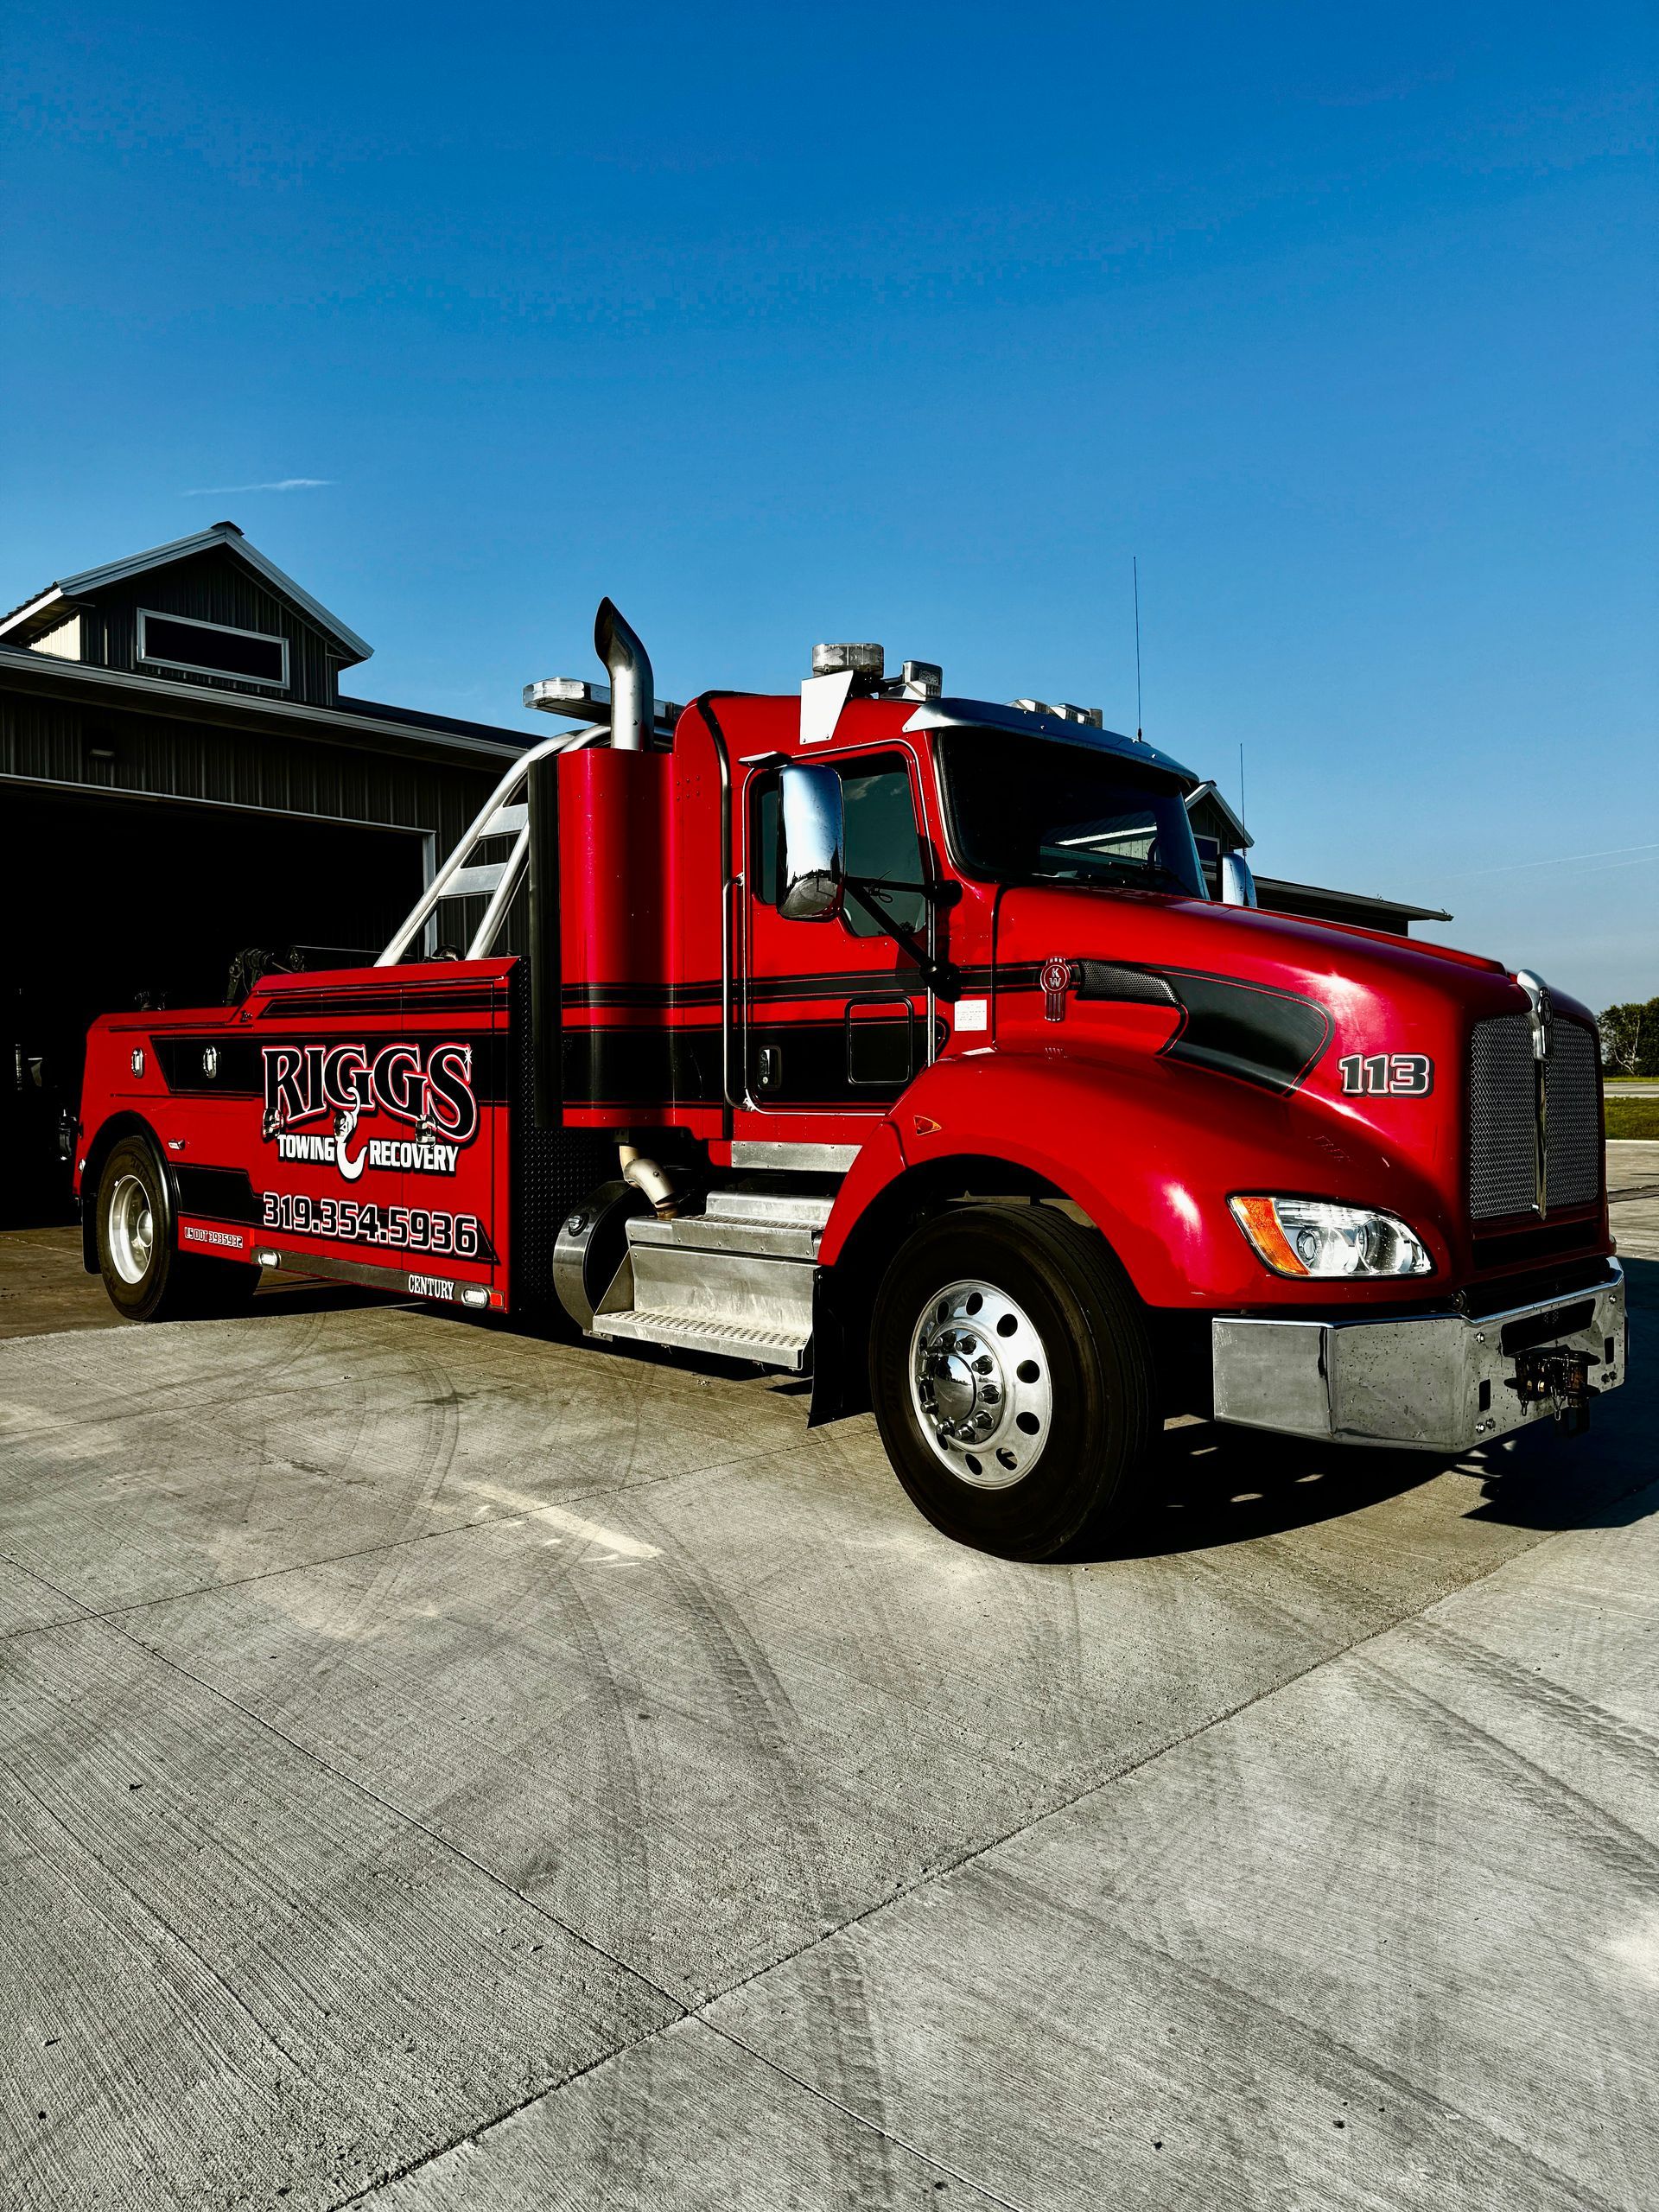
<box><xmin>909</xmin><ymin>1281</ymin><xmax>1055</xmax><ymax>1491</ymax></box>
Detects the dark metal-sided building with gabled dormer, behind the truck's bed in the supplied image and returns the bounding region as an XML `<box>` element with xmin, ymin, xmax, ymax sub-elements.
<box><xmin>0</xmin><ymin>522</ymin><xmax>529</xmax><ymax>1219</ymax></box>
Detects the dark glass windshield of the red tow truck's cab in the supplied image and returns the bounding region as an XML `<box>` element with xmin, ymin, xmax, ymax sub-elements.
<box><xmin>938</xmin><ymin>730</ymin><xmax>1205</xmax><ymax>898</ymax></box>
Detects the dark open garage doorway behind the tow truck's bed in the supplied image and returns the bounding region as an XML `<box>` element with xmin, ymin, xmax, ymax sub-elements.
<box><xmin>0</xmin><ymin>783</ymin><xmax>425</xmax><ymax>1224</ymax></box>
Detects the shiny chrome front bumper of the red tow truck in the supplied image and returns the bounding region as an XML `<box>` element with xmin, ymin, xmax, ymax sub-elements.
<box><xmin>1210</xmin><ymin>1261</ymin><xmax>1626</xmax><ymax>1451</ymax></box>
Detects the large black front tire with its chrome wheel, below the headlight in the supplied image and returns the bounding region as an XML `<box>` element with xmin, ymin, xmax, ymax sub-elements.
<box><xmin>869</xmin><ymin>1205</ymin><xmax>1154</xmax><ymax>1560</ymax></box>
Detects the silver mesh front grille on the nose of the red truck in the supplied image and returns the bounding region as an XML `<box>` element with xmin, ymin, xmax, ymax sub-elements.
<box><xmin>1469</xmin><ymin>1013</ymin><xmax>1601</xmax><ymax>1221</ymax></box>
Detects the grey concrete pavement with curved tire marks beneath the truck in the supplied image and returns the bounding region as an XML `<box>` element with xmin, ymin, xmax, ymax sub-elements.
<box><xmin>0</xmin><ymin>1211</ymin><xmax>1659</xmax><ymax>2212</ymax></box>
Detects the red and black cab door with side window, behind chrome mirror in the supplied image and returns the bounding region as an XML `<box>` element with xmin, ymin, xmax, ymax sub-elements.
<box><xmin>734</xmin><ymin>750</ymin><xmax>931</xmax><ymax>1141</ymax></box>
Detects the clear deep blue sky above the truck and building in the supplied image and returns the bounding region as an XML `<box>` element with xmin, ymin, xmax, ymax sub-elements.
<box><xmin>0</xmin><ymin>0</ymin><xmax>1659</xmax><ymax>1004</ymax></box>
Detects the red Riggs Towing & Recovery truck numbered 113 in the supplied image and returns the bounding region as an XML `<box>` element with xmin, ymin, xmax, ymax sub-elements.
<box><xmin>75</xmin><ymin>601</ymin><xmax>1626</xmax><ymax>1560</ymax></box>
